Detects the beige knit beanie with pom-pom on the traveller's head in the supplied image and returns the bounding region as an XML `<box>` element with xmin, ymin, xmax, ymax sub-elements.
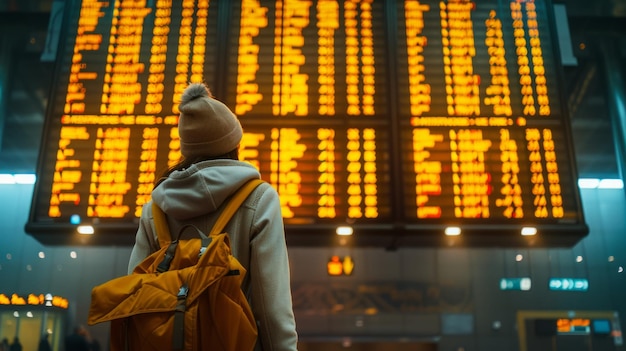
<box><xmin>178</xmin><ymin>83</ymin><xmax>243</xmax><ymax>159</ymax></box>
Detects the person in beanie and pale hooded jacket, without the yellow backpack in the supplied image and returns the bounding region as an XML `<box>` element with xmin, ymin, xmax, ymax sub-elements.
<box><xmin>128</xmin><ymin>83</ymin><xmax>297</xmax><ymax>350</ymax></box>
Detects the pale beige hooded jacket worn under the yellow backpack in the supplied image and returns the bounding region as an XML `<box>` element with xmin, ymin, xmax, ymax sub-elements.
<box><xmin>128</xmin><ymin>159</ymin><xmax>297</xmax><ymax>350</ymax></box>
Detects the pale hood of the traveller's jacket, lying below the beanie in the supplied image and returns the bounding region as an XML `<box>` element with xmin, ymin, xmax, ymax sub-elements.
<box><xmin>152</xmin><ymin>159</ymin><xmax>260</xmax><ymax>220</ymax></box>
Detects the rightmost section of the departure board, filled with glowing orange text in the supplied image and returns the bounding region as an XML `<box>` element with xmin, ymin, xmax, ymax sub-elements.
<box><xmin>396</xmin><ymin>1</ymin><xmax>584</xmax><ymax>239</ymax></box>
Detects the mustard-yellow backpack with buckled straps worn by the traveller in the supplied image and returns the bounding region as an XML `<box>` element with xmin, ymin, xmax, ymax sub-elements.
<box><xmin>88</xmin><ymin>179</ymin><xmax>263</xmax><ymax>351</ymax></box>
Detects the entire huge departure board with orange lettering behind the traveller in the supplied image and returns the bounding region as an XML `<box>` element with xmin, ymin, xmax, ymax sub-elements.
<box><xmin>26</xmin><ymin>0</ymin><xmax>588</xmax><ymax>246</ymax></box>
